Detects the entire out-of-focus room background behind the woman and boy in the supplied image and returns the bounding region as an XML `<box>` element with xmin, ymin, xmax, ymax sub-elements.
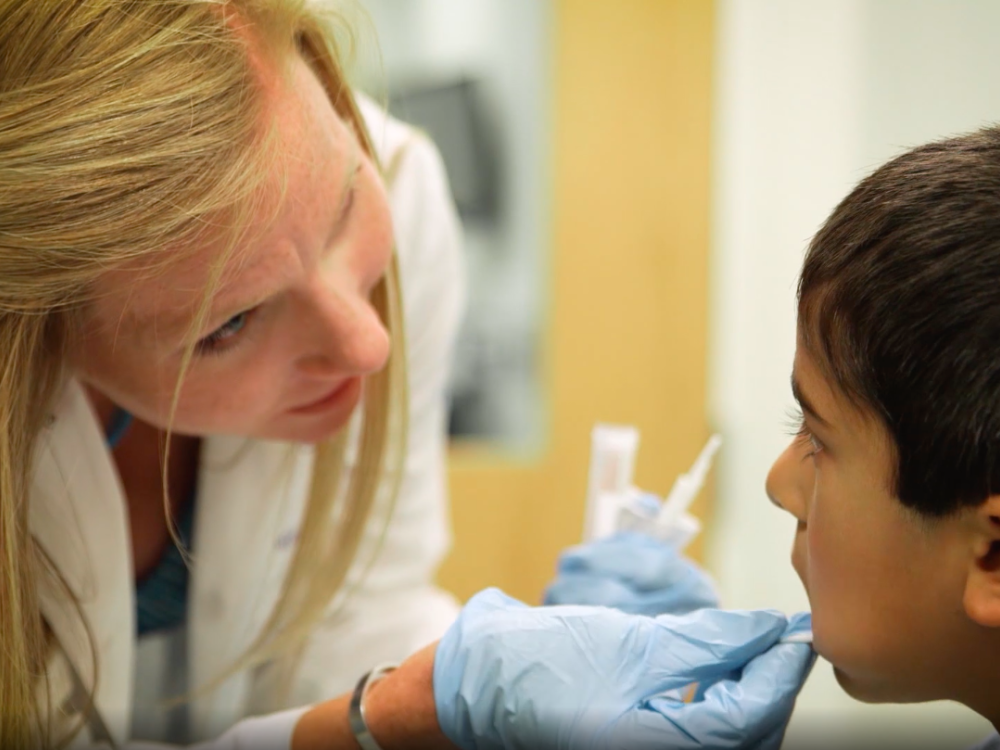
<box><xmin>350</xmin><ymin>0</ymin><xmax>1000</xmax><ymax>748</ymax></box>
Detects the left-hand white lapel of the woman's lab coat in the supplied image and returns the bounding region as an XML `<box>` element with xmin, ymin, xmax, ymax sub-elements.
<box><xmin>29</xmin><ymin>381</ymin><xmax>135</xmax><ymax>744</ymax></box>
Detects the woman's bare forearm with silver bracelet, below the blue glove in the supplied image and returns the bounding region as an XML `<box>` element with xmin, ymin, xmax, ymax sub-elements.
<box><xmin>292</xmin><ymin>646</ymin><xmax>455</xmax><ymax>750</ymax></box>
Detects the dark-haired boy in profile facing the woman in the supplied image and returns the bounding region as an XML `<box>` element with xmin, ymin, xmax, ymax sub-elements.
<box><xmin>767</xmin><ymin>128</ymin><xmax>1000</xmax><ymax>744</ymax></box>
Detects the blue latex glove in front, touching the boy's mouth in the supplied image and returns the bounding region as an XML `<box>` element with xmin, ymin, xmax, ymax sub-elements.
<box><xmin>434</xmin><ymin>589</ymin><xmax>815</xmax><ymax>750</ymax></box>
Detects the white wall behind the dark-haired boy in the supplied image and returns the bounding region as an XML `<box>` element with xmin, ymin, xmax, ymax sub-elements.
<box><xmin>709</xmin><ymin>0</ymin><xmax>1000</xmax><ymax>748</ymax></box>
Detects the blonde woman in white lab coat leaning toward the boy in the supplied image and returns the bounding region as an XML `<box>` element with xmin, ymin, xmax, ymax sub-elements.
<box><xmin>0</xmin><ymin>0</ymin><xmax>808</xmax><ymax>748</ymax></box>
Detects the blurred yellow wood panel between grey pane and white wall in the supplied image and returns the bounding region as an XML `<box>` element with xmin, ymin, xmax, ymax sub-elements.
<box><xmin>441</xmin><ymin>0</ymin><xmax>714</xmax><ymax>601</ymax></box>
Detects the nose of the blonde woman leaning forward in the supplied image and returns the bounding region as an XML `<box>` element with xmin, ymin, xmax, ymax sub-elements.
<box><xmin>298</xmin><ymin>288</ymin><xmax>391</xmax><ymax>377</ymax></box>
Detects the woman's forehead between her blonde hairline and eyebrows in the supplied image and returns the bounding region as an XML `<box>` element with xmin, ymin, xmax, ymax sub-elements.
<box><xmin>90</xmin><ymin>59</ymin><xmax>359</xmax><ymax>350</ymax></box>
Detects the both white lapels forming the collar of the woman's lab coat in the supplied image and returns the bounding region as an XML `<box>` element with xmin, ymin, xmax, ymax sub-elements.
<box><xmin>29</xmin><ymin>380</ymin><xmax>314</xmax><ymax>744</ymax></box>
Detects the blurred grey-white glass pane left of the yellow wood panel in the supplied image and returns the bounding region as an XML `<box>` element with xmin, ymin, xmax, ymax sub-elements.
<box><xmin>355</xmin><ymin>0</ymin><xmax>552</xmax><ymax>452</ymax></box>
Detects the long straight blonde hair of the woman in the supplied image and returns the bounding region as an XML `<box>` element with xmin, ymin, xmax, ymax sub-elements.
<box><xmin>0</xmin><ymin>0</ymin><xmax>407</xmax><ymax>747</ymax></box>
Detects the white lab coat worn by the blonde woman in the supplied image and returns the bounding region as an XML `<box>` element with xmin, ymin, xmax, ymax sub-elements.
<box><xmin>30</xmin><ymin>102</ymin><xmax>464</xmax><ymax>750</ymax></box>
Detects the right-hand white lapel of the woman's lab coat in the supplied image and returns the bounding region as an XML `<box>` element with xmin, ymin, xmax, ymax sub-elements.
<box><xmin>188</xmin><ymin>437</ymin><xmax>312</xmax><ymax>739</ymax></box>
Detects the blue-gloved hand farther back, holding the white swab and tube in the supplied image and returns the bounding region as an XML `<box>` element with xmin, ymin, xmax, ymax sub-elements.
<box><xmin>545</xmin><ymin>532</ymin><xmax>719</xmax><ymax>615</ymax></box>
